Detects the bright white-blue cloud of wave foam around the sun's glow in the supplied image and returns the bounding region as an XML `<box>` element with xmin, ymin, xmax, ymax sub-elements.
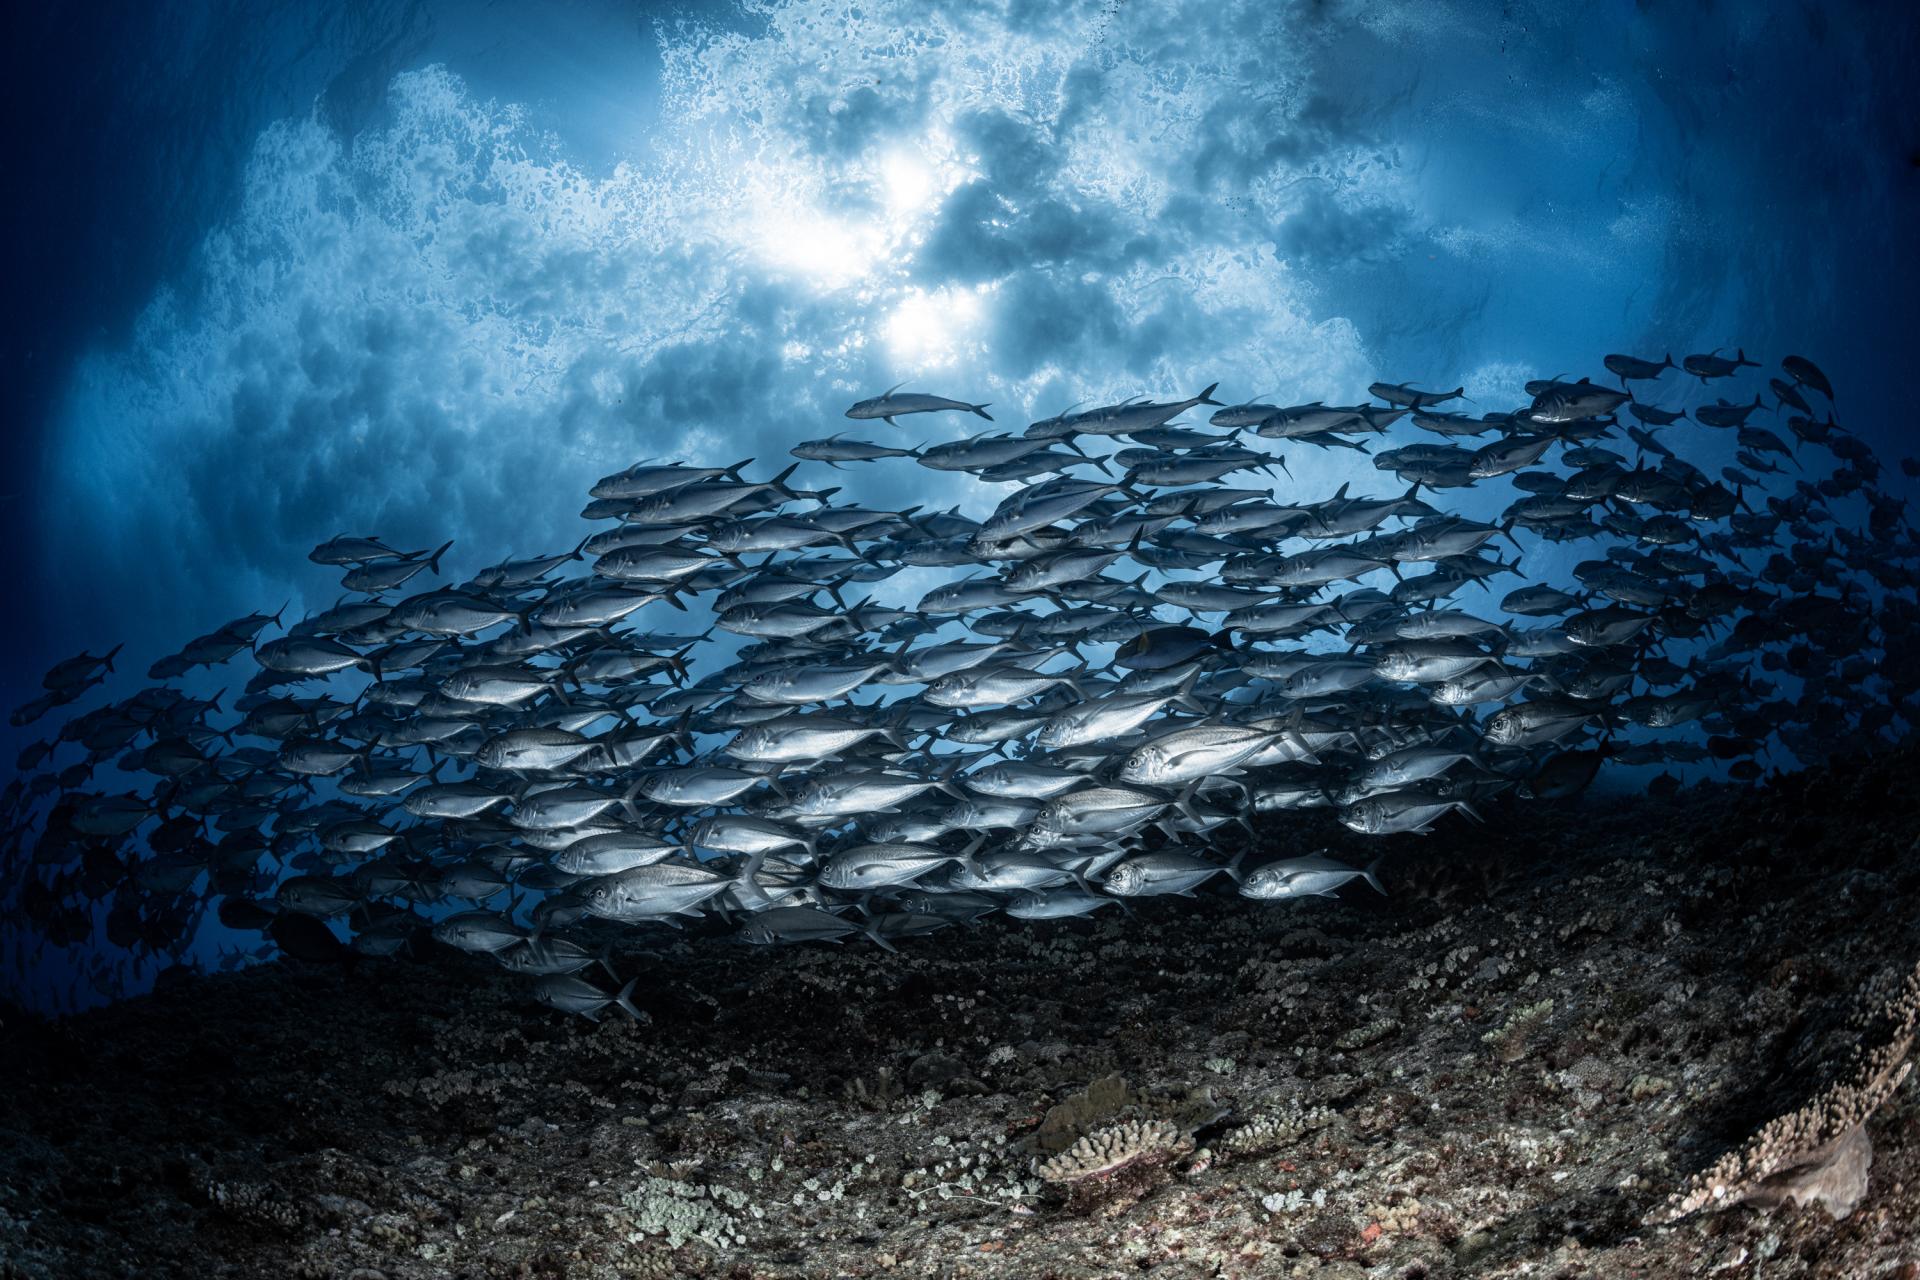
<box><xmin>42</xmin><ymin>4</ymin><xmax>1371</xmax><ymax>639</ymax></box>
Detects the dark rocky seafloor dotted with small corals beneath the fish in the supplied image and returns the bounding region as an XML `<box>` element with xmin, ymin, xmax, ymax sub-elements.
<box><xmin>0</xmin><ymin>750</ymin><xmax>1920</xmax><ymax>1280</ymax></box>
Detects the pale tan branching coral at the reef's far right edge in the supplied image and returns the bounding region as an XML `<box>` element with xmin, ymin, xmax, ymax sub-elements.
<box><xmin>1647</xmin><ymin>965</ymin><xmax>1920</xmax><ymax>1222</ymax></box>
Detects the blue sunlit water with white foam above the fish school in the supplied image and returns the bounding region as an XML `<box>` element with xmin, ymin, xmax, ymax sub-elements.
<box><xmin>0</xmin><ymin>0</ymin><xmax>1920</xmax><ymax>1013</ymax></box>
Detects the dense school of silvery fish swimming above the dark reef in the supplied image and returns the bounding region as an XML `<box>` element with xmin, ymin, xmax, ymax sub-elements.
<box><xmin>0</xmin><ymin>351</ymin><xmax>1920</xmax><ymax>1019</ymax></box>
